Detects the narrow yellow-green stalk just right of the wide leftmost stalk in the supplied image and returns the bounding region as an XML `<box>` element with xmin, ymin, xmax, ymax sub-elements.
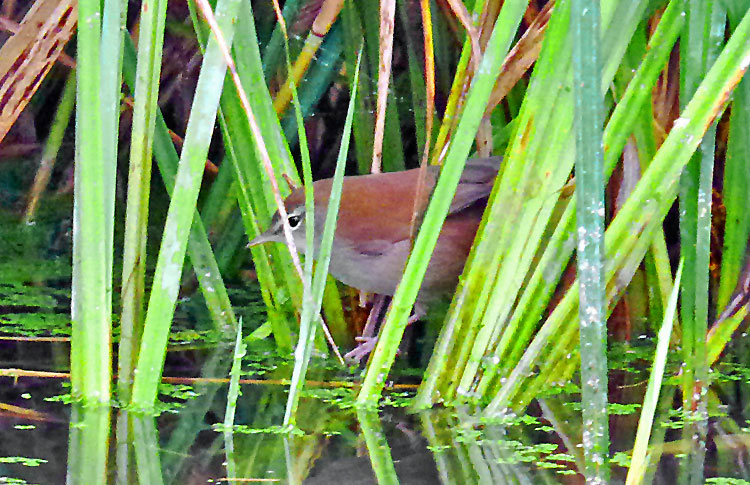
<box><xmin>117</xmin><ymin>0</ymin><xmax>167</xmax><ymax>402</ymax></box>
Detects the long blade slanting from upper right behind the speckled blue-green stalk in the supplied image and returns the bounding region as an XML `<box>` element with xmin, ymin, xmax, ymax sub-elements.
<box><xmin>486</xmin><ymin>3</ymin><xmax>750</xmax><ymax>414</ymax></box>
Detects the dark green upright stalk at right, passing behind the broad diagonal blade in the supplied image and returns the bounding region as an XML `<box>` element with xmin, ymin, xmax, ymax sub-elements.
<box><xmin>680</xmin><ymin>0</ymin><xmax>726</xmax><ymax>480</ymax></box>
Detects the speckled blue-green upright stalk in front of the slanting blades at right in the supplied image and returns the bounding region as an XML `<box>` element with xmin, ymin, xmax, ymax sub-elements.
<box><xmin>570</xmin><ymin>0</ymin><xmax>609</xmax><ymax>483</ymax></box>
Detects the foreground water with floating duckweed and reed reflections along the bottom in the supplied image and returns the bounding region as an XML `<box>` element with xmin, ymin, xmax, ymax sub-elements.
<box><xmin>0</xmin><ymin>364</ymin><xmax>750</xmax><ymax>485</ymax></box>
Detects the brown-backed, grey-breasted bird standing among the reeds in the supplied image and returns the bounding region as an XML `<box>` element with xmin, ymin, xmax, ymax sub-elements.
<box><xmin>248</xmin><ymin>157</ymin><xmax>501</xmax><ymax>358</ymax></box>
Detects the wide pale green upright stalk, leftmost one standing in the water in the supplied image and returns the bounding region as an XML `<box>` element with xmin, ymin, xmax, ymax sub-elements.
<box><xmin>71</xmin><ymin>0</ymin><xmax>114</xmax><ymax>402</ymax></box>
